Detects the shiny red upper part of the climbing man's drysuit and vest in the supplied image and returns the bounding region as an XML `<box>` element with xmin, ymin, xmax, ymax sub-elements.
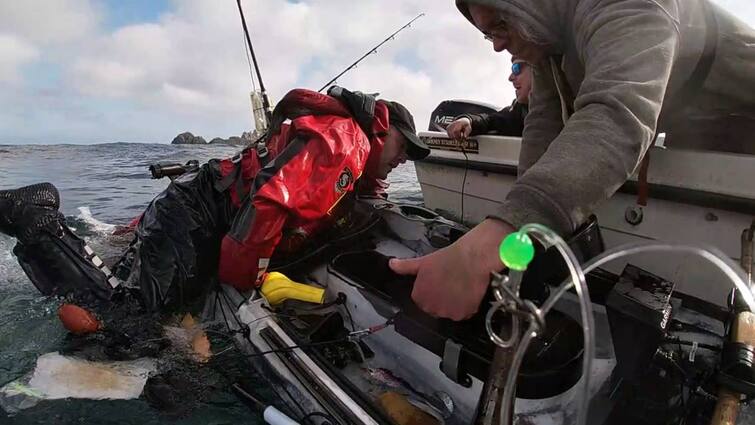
<box><xmin>214</xmin><ymin>89</ymin><xmax>388</xmax><ymax>290</ymax></box>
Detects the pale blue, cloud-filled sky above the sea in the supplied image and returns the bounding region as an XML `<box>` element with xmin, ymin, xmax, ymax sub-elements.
<box><xmin>0</xmin><ymin>0</ymin><xmax>755</xmax><ymax>144</ymax></box>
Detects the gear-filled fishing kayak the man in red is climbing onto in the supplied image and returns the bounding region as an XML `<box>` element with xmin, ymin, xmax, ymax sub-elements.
<box><xmin>204</xmin><ymin>200</ymin><xmax>752</xmax><ymax>424</ymax></box>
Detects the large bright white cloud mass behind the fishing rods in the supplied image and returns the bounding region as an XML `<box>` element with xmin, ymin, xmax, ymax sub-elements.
<box><xmin>53</xmin><ymin>0</ymin><xmax>513</xmax><ymax>140</ymax></box>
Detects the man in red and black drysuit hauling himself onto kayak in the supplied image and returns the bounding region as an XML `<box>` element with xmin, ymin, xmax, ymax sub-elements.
<box><xmin>0</xmin><ymin>87</ymin><xmax>429</xmax><ymax>311</ymax></box>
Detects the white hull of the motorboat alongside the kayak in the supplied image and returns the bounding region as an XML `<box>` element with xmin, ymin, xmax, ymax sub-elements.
<box><xmin>415</xmin><ymin>132</ymin><xmax>755</xmax><ymax>305</ymax></box>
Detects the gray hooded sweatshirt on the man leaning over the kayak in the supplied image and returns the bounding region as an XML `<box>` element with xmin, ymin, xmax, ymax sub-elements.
<box><xmin>456</xmin><ymin>0</ymin><xmax>755</xmax><ymax>235</ymax></box>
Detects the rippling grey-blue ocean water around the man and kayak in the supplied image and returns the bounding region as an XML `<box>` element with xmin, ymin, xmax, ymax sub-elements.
<box><xmin>0</xmin><ymin>143</ymin><xmax>422</xmax><ymax>425</ymax></box>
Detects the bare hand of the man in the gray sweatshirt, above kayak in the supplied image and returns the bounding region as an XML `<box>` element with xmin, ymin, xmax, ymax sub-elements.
<box><xmin>388</xmin><ymin>219</ymin><xmax>514</xmax><ymax>320</ymax></box>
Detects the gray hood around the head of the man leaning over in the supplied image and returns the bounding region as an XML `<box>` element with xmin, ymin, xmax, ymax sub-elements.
<box><xmin>456</xmin><ymin>0</ymin><xmax>582</xmax><ymax>48</ymax></box>
